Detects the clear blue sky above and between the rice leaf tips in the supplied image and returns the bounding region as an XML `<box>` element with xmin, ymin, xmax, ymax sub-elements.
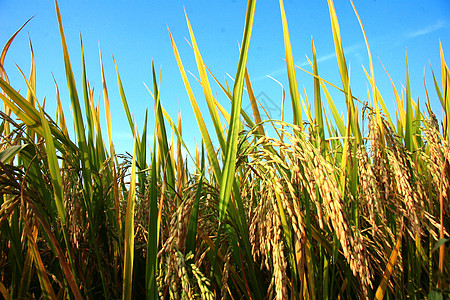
<box><xmin>0</xmin><ymin>0</ymin><xmax>450</xmax><ymax>157</ymax></box>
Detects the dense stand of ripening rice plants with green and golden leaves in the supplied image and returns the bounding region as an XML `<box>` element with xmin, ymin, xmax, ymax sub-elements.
<box><xmin>0</xmin><ymin>0</ymin><xmax>450</xmax><ymax>299</ymax></box>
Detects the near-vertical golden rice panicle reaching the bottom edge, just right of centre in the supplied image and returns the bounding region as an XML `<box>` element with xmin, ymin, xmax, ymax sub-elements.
<box><xmin>244</xmin><ymin>138</ymin><xmax>296</xmax><ymax>299</ymax></box>
